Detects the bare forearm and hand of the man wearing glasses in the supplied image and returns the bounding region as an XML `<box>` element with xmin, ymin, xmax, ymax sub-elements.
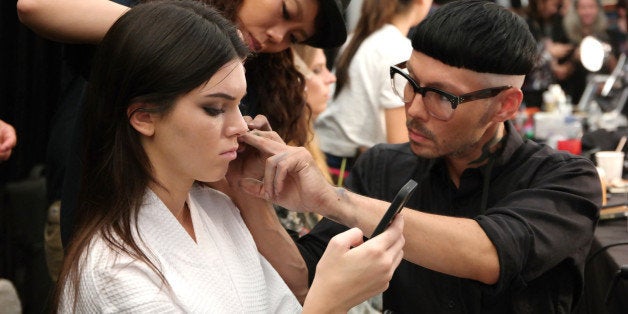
<box><xmin>241</xmin><ymin>132</ymin><xmax>500</xmax><ymax>284</ymax></box>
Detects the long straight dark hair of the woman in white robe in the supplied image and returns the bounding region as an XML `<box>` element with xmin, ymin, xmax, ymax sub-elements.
<box><xmin>54</xmin><ymin>0</ymin><xmax>248</xmax><ymax>309</ymax></box>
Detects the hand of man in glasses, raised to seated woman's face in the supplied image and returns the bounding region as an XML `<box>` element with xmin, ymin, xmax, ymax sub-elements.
<box><xmin>239</xmin><ymin>131</ymin><xmax>336</xmax><ymax>215</ymax></box>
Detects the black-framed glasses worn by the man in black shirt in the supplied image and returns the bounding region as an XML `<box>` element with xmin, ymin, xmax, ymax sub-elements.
<box><xmin>390</xmin><ymin>62</ymin><xmax>512</xmax><ymax>121</ymax></box>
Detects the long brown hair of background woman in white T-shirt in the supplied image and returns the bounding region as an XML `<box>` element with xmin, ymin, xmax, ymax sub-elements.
<box><xmin>334</xmin><ymin>0</ymin><xmax>412</xmax><ymax>98</ymax></box>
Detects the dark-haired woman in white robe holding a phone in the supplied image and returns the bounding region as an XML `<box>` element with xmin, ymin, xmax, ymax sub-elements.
<box><xmin>53</xmin><ymin>1</ymin><xmax>404</xmax><ymax>313</ymax></box>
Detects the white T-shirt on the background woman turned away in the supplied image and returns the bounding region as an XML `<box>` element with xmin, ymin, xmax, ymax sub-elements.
<box><xmin>314</xmin><ymin>24</ymin><xmax>412</xmax><ymax>157</ymax></box>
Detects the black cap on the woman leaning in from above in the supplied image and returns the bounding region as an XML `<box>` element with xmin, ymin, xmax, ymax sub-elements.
<box><xmin>304</xmin><ymin>0</ymin><xmax>351</xmax><ymax>48</ymax></box>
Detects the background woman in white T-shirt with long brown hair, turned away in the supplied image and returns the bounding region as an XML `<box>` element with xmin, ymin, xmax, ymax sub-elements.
<box><xmin>315</xmin><ymin>0</ymin><xmax>432</xmax><ymax>185</ymax></box>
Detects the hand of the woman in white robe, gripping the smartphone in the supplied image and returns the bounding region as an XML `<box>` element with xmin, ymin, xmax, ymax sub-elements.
<box><xmin>303</xmin><ymin>215</ymin><xmax>405</xmax><ymax>313</ymax></box>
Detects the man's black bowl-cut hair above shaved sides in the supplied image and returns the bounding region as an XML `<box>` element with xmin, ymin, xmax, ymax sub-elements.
<box><xmin>412</xmin><ymin>0</ymin><xmax>537</xmax><ymax>75</ymax></box>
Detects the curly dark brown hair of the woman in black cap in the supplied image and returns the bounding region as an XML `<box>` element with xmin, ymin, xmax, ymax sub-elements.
<box><xmin>201</xmin><ymin>0</ymin><xmax>310</xmax><ymax>146</ymax></box>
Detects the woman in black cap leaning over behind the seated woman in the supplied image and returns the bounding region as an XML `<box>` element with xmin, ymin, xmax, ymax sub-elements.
<box><xmin>17</xmin><ymin>0</ymin><xmax>348</xmax><ymax>244</ymax></box>
